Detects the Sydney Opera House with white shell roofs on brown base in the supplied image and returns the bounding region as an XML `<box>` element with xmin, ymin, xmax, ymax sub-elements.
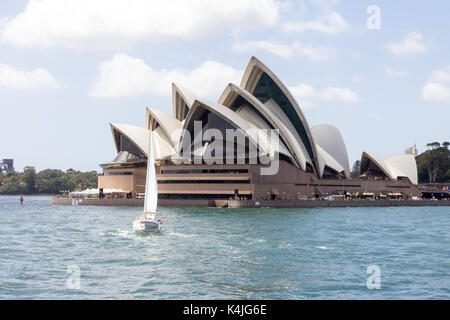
<box><xmin>98</xmin><ymin>57</ymin><xmax>421</xmax><ymax>200</ymax></box>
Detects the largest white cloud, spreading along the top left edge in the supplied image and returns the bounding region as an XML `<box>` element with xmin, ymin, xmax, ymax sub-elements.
<box><xmin>0</xmin><ymin>0</ymin><xmax>279</xmax><ymax>48</ymax></box>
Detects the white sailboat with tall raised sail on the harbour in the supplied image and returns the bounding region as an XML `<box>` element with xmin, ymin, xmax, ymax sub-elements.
<box><xmin>133</xmin><ymin>129</ymin><xmax>162</xmax><ymax>232</ymax></box>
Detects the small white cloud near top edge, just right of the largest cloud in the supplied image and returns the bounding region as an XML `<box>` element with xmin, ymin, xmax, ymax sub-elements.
<box><xmin>282</xmin><ymin>12</ymin><xmax>350</xmax><ymax>34</ymax></box>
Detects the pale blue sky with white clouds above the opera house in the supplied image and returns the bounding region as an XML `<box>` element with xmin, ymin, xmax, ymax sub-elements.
<box><xmin>0</xmin><ymin>0</ymin><xmax>450</xmax><ymax>171</ymax></box>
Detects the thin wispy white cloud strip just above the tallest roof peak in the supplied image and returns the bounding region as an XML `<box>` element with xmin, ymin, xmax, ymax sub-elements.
<box><xmin>233</xmin><ymin>41</ymin><xmax>334</xmax><ymax>61</ymax></box>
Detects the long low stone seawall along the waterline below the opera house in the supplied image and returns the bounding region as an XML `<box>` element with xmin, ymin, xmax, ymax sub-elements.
<box><xmin>51</xmin><ymin>197</ymin><xmax>450</xmax><ymax>208</ymax></box>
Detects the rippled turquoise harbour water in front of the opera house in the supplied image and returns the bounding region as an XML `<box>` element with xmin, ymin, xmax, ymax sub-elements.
<box><xmin>0</xmin><ymin>196</ymin><xmax>450</xmax><ymax>299</ymax></box>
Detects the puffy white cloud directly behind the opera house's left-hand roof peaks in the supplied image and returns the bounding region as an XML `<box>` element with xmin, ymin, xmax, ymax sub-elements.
<box><xmin>91</xmin><ymin>53</ymin><xmax>243</xmax><ymax>98</ymax></box>
